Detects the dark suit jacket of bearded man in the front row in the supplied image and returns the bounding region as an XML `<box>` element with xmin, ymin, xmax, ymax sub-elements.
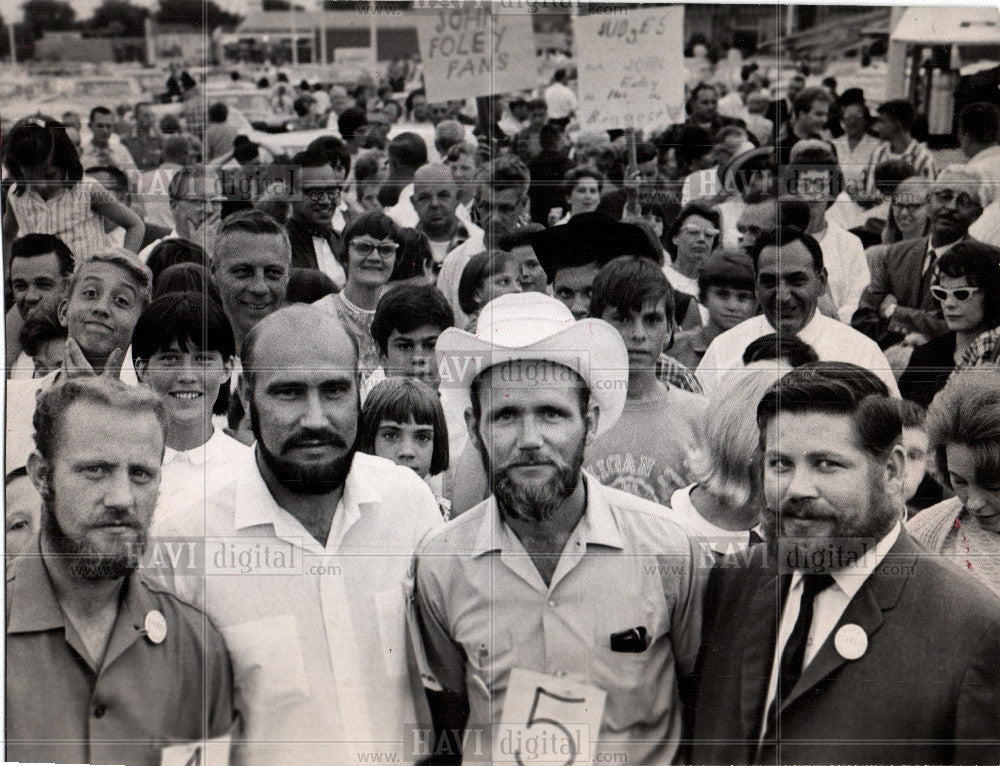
<box><xmin>687</xmin><ymin>531</ymin><xmax>1000</xmax><ymax>764</ymax></box>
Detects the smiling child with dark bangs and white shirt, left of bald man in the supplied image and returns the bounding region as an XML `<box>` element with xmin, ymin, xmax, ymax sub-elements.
<box><xmin>132</xmin><ymin>293</ymin><xmax>249</xmax><ymax>531</ymax></box>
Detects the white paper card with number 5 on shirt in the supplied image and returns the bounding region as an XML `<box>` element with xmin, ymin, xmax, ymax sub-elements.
<box><xmin>493</xmin><ymin>668</ymin><xmax>605</xmax><ymax>766</ymax></box>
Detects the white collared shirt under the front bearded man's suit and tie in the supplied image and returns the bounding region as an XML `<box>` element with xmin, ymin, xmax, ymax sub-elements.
<box><xmin>760</xmin><ymin>521</ymin><xmax>901</xmax><ymax>737</ymax></box>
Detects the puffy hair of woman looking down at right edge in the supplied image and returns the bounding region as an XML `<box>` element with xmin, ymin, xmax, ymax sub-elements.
<box><xmin>925</xmin><ymin>366</ymin><xmax>1000</xmax><ymax>484</ymax></box>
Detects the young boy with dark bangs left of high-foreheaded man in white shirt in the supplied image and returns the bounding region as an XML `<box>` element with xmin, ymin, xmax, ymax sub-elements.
<box><xmin>670</xmin><ymin>249</ymin><xmax>757</xmax><ymax>369</ymax></box>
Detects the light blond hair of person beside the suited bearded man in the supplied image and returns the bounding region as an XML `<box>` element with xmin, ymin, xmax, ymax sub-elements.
<box><xmin>688</xmin><ymin>362</ymin><xmax>792</xmax><ymax>508</ymax></box>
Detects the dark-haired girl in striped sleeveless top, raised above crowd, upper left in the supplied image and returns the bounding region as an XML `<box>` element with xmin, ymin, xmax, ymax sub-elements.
<box><xmin>3</xmin><ymin>117</ymin><xmax>145</xmax><ymax>263</ymax></box>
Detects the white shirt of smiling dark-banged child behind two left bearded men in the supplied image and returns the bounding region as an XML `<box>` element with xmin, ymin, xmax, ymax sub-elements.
<box><xmin>152</xmin><ymin>430</ymin><xmax>251</xmax><ymax>534</ymax></box>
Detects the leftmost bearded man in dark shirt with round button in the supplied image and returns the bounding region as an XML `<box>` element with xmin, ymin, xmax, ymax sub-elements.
<box><xmin>6</xmin><ymin>377</ymin><xmax>234</xmax><ymax>766</ymax></box>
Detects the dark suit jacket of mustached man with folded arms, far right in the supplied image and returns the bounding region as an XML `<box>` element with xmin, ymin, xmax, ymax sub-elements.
<box><xmin>851</xmin><ymin>237</ymin><xmax>948</xmax><ymax>347</ymax></box>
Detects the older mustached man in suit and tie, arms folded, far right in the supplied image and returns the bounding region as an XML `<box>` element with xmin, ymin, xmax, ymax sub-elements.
<box><xmin>851</xmin><ymin>168</ymin><xmax>983</xmax><ymax>348</ymax></box>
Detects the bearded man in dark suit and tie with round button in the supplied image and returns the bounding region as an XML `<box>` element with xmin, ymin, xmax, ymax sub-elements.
<box><xmin>687</xmin><ymin>362</ymin><xmax>1000</xmax><ymax>764</ymax></box>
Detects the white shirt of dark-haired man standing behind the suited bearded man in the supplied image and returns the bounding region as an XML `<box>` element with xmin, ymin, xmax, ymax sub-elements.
<box><xmin>695</xmin><ymin>311</ymin><xmax>899</xmax><ymax>397</ymax></box>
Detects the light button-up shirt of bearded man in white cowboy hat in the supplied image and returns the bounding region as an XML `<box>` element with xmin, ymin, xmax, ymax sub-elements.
<box><xmin>415</xmin><ymin>473</ymin><xmax>708</xmax><ymax>764</ymax></box>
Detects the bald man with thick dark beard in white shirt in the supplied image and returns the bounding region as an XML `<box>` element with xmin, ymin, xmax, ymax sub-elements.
<box><xmin>154</xmin><ymin>306</ymin><xmax>443</xmax><ymax>766</ymax></box>
